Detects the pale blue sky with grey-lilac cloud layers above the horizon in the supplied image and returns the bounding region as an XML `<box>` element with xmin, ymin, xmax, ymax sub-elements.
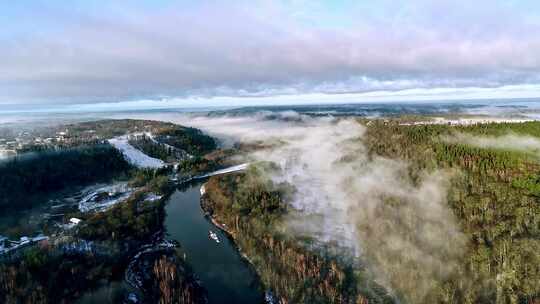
<box><xmin>0</xmin><ymin>0</ymin><xmax>540</xmax><ymax>108</ymax></box>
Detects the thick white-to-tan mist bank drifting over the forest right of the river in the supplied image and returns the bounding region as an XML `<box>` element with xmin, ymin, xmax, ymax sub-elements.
<box><xmin>150</xmin><ymin>111</ymin><xmax>466</xmax><ymax>303</ymax></box>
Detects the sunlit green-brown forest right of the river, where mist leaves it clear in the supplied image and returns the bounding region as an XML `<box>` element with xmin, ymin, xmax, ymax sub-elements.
<box><xmin>203</xmin><ymin>119</ymin><xmax>540</xmax><ymax>303</ymax></box>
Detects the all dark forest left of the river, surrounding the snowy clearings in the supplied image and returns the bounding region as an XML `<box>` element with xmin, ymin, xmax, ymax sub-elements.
<box><xmin>0</xmin><ymin>120</ymin><xmax>215</xmax><ymax>303</ymax></box>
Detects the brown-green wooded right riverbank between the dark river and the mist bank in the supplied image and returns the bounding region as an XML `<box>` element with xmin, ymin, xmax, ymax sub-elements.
<box><xmin>201</xmin><ymin>169</ymin><xmax>391</xmax><ymax>304</ymax></box>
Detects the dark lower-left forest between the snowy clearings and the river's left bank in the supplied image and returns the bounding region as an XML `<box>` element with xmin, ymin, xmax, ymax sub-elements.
<box><xmin>0</xmin><ymin>165</ymin><xmax>206</xmax><ymax>304</ymax></box>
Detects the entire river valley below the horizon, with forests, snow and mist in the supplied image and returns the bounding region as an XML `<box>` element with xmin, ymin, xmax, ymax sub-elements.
<box><xmin>0</xmin><ymin>113</ymin><xmax>540</xmax><ymax>304</ymax></box>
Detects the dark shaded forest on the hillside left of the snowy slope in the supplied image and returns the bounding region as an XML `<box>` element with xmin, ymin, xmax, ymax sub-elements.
<box><xmin>0</xmin><ymin>144</ymin><xmax>131</xmax><ymax>210</ymax></box>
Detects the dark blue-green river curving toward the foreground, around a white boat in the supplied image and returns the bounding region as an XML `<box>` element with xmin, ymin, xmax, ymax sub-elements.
<box><xmin>165</xmin><ymin>183</ymin><xmax>264</xmax><ymax>304</ymax></box>
